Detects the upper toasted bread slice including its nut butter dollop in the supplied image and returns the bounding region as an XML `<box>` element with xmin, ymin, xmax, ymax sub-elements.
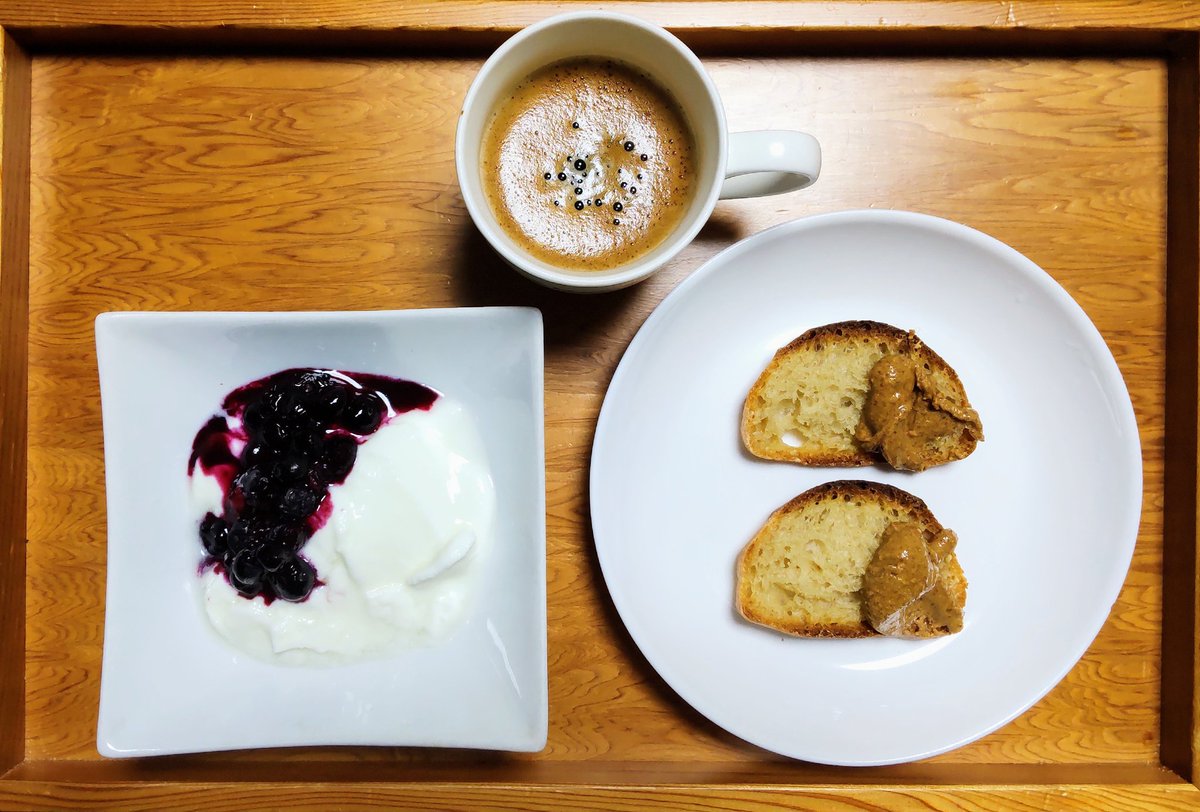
<box><xmin>742</xmin><ymin>321</ymin><xmax>983</xmax><ymax>471</ymax></box>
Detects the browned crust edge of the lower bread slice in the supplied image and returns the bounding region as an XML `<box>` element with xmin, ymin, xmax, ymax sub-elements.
<box><xmin>734</xmin><ymin>480</ymin><xmax>967</xmax><ymax>638</ymax></box>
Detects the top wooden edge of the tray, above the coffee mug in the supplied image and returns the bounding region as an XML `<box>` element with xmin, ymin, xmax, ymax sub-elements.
<box><xmin>0</xmin><ymin>0</ymin><xmax>1200</xmax><ymax>37</ymax></box>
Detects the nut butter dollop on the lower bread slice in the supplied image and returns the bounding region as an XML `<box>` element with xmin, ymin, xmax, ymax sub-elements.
<box><xmin>863</xmin><ymin>522</ymin><xmax>962</xmax><ymax>637</ymax></box>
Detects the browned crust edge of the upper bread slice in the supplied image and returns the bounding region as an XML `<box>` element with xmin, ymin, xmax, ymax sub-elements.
<box><xmin>740</xmin><ymin>319</ymin><xmax>977</xmax><ymax>468</ymax></box>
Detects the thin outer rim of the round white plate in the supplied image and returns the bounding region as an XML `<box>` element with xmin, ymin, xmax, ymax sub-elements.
<box><xmin>588</xmin><ymin>209</ymin><xmax>1145</xmax><ymax>766</ymax></box>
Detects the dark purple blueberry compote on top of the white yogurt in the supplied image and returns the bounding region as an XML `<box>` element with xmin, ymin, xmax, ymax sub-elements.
<box><xmin>187</xmin><ymin>369</ymin><xmax>438</xmax><ymax>603</ymax></box>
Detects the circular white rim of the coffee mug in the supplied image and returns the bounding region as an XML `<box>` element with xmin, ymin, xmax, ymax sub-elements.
<box><xmin>455</xmin><ymin>11</ymin><xmax>728</xmax><ymax>291</ymax></box>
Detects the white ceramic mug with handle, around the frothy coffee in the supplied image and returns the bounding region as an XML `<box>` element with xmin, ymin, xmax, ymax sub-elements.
<box><xmin>455</xmin><ymin>12</ymin><xmax>821</xmax><ymax>291</ymax></box>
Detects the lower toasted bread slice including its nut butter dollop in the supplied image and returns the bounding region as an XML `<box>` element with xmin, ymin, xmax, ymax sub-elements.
<box><xmin>736</xmin><ymin>480</ymin><xmax>967</xmax><ymax>638</ymax></box>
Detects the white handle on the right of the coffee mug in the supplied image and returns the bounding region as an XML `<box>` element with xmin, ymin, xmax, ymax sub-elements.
<box><xmin>721</xmin><ymin>130</ymin><xmax>821</xmax><ymax>200</ymax></box>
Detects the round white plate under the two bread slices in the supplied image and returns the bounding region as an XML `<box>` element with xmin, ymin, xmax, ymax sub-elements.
<box><xmin>592</xmin><ymin>211</ymin><xmax>1141</xmax><ymax>765</ymax></box>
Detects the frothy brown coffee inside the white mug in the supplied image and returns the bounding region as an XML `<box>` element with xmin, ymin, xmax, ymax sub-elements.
<box><xmin>480</xmin><ymin>59</ymin><xmax>695</xmax><ymax>271</ymax></box>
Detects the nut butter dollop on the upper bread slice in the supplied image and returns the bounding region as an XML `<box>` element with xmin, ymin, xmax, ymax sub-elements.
<box><xmin>854</xmin><ymin>355</ymin><xmax>983</xmax><ymax>471</ymax></box>
